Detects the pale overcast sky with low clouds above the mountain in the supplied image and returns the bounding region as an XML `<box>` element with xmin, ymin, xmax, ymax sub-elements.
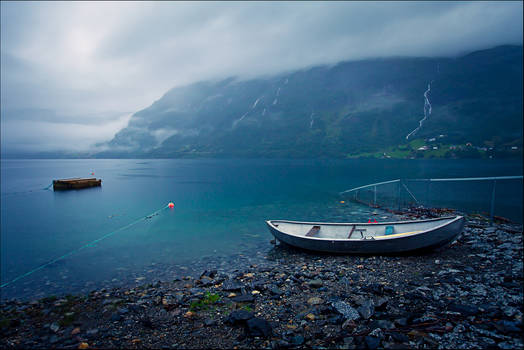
<box><xmin>1</xmin><ymin>1</ymin><xmax>523</xmax><ymax>152</ymax></box>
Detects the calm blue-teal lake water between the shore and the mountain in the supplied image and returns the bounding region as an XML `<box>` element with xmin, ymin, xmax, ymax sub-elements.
<box><xmin>1</xmin><ymin>159</ymin><xmax>522</xmax><ymax>299</ymax></box>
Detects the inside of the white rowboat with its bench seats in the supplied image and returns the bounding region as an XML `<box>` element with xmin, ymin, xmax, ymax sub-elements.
<box><xmin>269</xmin><ymin>217</ymin><xmax>456</xmax><ymax>240</ymax></box>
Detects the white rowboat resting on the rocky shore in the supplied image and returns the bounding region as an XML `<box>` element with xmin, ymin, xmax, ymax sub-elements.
<box><xmin>266</xmin><ymin>216</ymin><xmax>464</xmax><ymax>254</ymax></box>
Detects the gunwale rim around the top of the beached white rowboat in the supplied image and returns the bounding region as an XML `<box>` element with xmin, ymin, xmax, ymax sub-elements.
<box><xmin>266</xmin><ymin>215</ymin><xmax>463</xmax><ymax>242</ymax></box>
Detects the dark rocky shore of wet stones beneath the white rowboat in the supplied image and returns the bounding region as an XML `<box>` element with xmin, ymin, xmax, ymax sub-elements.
<box><xmin>0</xmin><ymin>212</ymin><xmax>523</xmax><ymax>349</ymax></box>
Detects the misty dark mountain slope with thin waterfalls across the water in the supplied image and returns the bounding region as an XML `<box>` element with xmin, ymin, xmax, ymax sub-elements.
<box><xmin>96</xmin><ymin>46</ymin><xmax>523</xmax><ymax>158</ymax></box>
